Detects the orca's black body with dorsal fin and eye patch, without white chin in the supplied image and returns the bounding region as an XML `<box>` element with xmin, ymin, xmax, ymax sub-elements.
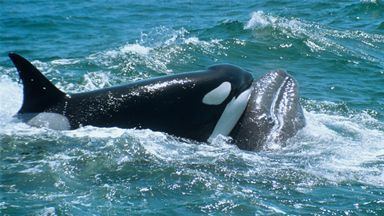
<box><xmin>9</xmin><ymin>53</ymin><xmax>253</xmax><ymax>141</ymax></box>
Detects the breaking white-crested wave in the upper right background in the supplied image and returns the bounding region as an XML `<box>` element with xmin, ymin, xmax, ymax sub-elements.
<box><xmin>244</xmin><ymin>11</ymin><xmax>384</xmax><ymax>64</ymax></box>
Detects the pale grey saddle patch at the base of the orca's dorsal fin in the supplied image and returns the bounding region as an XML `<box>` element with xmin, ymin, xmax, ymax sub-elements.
<box><xmin>27</xmin><ymin>112</ymin><xmax>71</xmax><ymax>130</ymax></box>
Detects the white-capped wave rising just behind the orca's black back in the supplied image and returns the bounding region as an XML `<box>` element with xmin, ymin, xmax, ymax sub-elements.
<box><xmin>0</xmin><ymin>27</ymin><xmax>231</xmax><ymax>92</ymax></box>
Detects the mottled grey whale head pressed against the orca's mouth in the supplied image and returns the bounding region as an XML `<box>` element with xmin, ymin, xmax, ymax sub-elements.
<box><xmin>231</xmin><ymin>71</ymin><xmax>305</xmax><ymax>151</ymax></box>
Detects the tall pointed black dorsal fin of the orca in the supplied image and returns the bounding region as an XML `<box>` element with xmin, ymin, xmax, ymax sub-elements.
<box><xmin>8</xmin><ymin>53</ymin><xmax>66</xmax><ymax>113</ymax></box>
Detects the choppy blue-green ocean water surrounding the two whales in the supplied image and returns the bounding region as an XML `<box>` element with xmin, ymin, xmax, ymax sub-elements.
<box><xmin>0</xmin><ymin>0</ymin><xmax>384</xmax><ymax>215</ymax></box>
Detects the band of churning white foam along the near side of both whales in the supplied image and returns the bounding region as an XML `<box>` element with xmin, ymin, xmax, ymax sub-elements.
<box><xmin>0</xmin><ymin>78</ymin><xmax>384</xmax><ymax>187</ymax></box>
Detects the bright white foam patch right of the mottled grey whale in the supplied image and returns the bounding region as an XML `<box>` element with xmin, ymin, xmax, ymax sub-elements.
<box><xmin>277</xmin><ymin>106</ymin><xmax>384</xmax><ymax>186</ymax></box>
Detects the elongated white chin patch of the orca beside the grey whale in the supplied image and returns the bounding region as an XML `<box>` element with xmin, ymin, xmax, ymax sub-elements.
<box><xmin>208</xmin><ymin>88</ymin><xmax>252</xmax><ymax>142</ymax></box>
